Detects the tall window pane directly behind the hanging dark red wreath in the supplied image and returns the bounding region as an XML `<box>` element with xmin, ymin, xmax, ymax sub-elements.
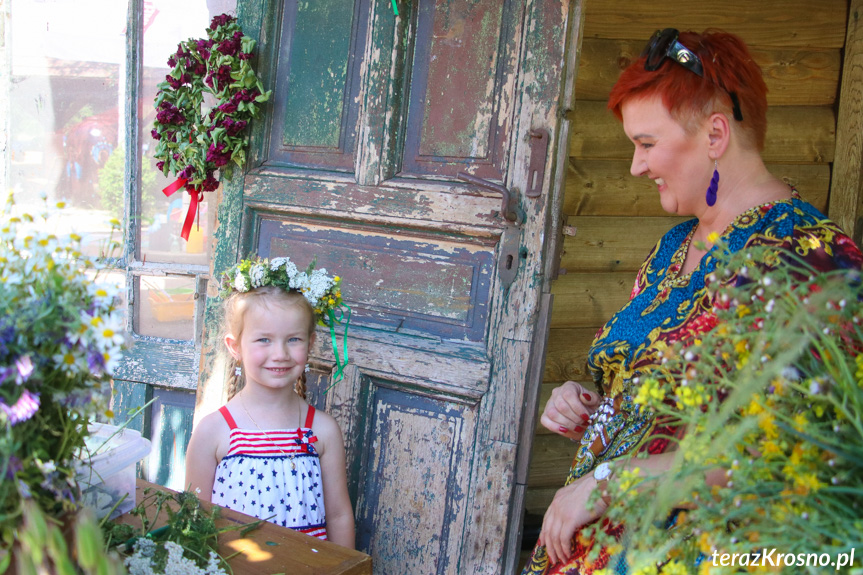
<box><xmin>140</xmin><ymin>0</ymin><xmax>237</xmax><ymax>265</ymax></box>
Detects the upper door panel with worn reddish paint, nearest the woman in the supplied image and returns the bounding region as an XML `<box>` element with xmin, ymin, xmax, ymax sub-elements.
<box><xmin>402</xmin><ymin>0</ymin><xmax>521</xmax><ymax>179</ymax></box>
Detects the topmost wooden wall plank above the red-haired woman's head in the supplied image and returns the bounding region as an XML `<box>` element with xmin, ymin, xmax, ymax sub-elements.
<box><xmin>584</xmin><ymin>0</ymin><xmax>848</xmax><ymax>48</ymax></box>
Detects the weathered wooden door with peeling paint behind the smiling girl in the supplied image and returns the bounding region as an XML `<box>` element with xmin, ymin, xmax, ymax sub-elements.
<box><xmin>198</xmin><ymin>0</ymin><xmax>578</xmax><ymax>574</ymax></box>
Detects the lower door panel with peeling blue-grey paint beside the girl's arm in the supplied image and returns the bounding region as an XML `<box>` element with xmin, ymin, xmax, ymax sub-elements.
<box><xmin>356</xmin><ymin>380</ymin><xmax>475</xmax><ymax>574</ymax></box>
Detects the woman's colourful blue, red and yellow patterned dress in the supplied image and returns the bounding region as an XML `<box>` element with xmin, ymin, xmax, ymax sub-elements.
<box><xmin>523</xmin><ymin>195</ymin><xmax>863</xmax><ymax>575</ymax></box>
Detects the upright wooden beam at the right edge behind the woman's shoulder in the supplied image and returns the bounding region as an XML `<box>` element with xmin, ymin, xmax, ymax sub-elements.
<box><xmin>829</xmin><ymin>0</ymin><xmax>863</xmax><ymax>245</ymax></box>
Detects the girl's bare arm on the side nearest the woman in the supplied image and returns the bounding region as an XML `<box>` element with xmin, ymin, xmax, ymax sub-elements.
<box><xmin>314</xmin><ymin>411</ymin><xmax>356</xmax><ymax>549</ymax></box>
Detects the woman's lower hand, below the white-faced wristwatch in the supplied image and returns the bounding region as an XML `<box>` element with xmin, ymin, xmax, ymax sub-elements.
<box><xmin>539</xmin><ymin>474</ymin><xmax>608</xmax><ymax>565</ymax></box>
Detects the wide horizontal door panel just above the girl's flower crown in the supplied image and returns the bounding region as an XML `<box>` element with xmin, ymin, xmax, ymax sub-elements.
<box><xmin>256</xmin><ymin>217</ymin><xmax>494</xmax><ymax>341</ymax></box>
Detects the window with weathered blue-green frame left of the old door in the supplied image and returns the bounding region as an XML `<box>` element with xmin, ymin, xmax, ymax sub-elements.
<box><xmin>0</xmin><ymin>0</ymin><xmax>236</xmax><ymax>488</ymax></box>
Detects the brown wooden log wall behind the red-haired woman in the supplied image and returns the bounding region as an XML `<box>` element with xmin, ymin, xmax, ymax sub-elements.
<box><xmin>526</xmin><ymin>0</ymin><xmax>859</xmax><ymax>522</ymax></box>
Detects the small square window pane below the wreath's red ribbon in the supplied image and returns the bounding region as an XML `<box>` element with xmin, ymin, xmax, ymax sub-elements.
<box><xmin>135</xmin><ymin>276</ymin><xmax>195</xmax><ymax>341</ymax></box>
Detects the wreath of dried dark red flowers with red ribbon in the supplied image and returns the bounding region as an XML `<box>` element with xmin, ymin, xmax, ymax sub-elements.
<box><xmin>151</xmin><ymin>14</ymin><xmax>272</xmax><ymax>240</ymax></box>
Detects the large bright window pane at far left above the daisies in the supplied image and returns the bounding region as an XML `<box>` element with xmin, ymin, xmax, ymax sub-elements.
<box><xmin>7</xmin><ymin>0</ymin><xmax>127</xmax><ymax>254</ymax></box>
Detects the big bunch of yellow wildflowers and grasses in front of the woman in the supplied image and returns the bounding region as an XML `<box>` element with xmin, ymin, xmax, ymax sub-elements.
<box><xmin>606</xmin><ymin>244</ymin><xmax>863</xmax><ymax>575</ymax></box>
